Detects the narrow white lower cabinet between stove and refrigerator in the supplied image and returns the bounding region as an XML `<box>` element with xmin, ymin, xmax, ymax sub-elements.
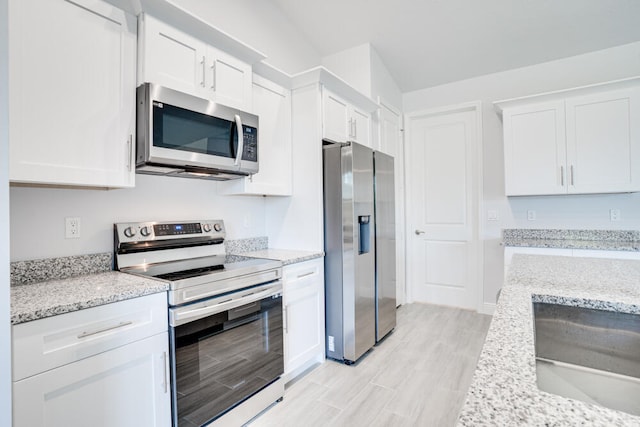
<box><xmin>283</xmin><ymin>258</ymin><xmax>324</xmax><ymax>381</ymax></box>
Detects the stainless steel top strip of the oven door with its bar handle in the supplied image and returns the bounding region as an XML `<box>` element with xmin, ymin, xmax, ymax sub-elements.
<box><xmin>169</xmin><ymin>280</ymin><xmax>282</xmax><ymax>327</ymax></box>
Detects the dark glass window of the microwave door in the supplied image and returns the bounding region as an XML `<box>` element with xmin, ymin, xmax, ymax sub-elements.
<box><xmin>153</xmin><ymin>102</ymin><xmax>238</xmax><ymax>159</ymax></box>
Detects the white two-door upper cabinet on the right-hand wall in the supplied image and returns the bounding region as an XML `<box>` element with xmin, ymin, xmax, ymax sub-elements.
<box><xmin>497</xmin><ymin>78</ymin><xmax>640</xmax><ymax>196</ymax></box>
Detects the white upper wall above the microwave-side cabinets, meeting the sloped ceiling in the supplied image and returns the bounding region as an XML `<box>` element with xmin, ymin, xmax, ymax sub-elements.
<box><xmin>174</xmin><ymin>0</ymin><xmax>320</xmax><ymax>74</ymax></box>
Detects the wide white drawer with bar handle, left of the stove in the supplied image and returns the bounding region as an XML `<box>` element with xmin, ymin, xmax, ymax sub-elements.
<box><xmin>13</xmin><ymin>292</ymin><xmax>167</xmax><ymax>381</ymax></box>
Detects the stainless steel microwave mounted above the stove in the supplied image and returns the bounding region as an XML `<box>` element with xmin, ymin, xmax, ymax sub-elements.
<box><xmin>136</xmin><ymin>83</ymin><xmax>258</xmax><ymax>180</ymax></box>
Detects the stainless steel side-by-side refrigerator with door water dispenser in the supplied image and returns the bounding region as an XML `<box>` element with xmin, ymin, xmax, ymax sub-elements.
<box><xmin>323</xmin><ymin>142</ymin><xmax>396</xmax><ymax>363</ymax></box>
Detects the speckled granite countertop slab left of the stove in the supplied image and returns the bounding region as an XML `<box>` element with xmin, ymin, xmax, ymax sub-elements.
<box><xmin>11</xmin><ymin>271</ymin><xmax>168</xmax><ymax>325</ymax></box>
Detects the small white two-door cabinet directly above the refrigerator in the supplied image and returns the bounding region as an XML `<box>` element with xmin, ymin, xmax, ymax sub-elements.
<box><xmin>322</xmin><ymin>87</ymin><xmax>371</xmax><ymax>147</ymax></box>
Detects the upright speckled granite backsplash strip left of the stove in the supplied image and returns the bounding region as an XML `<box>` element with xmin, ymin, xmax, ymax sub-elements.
<box><xmin>11</xmin><ymin>252</ymin><xmax>113</xmax><ymax>286</ymax></box>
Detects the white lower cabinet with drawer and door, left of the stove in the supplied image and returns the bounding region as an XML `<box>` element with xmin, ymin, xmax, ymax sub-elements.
<box><xmin>13</xmin><ymin>293</ymin><xmax>171</xmax><ymax>427</ymax></box>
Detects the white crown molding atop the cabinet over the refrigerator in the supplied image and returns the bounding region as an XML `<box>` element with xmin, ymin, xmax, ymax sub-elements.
<box><xmin>292</xmin><ymin>66</ymin><xmax>378</xmax><ymax>113</ymax></box>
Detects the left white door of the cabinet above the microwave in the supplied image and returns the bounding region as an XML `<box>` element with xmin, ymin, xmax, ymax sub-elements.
<box><xmin>138</xmin><ymin>15</ymin><xmax>211</xmax><ymax>98</ymax></box>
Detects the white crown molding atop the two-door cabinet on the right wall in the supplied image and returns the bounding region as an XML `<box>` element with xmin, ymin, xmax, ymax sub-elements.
<box><xmin>493</xmin><ymin>76</ymin><xmax>640</xmax><ymax>115</ymax></box>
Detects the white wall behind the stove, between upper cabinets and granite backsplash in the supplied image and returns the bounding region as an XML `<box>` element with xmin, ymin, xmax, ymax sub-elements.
<box><xmin>11</xmin><ymin>175</ymin><xmax>266</xmax><ymax>261</ymax></box>
